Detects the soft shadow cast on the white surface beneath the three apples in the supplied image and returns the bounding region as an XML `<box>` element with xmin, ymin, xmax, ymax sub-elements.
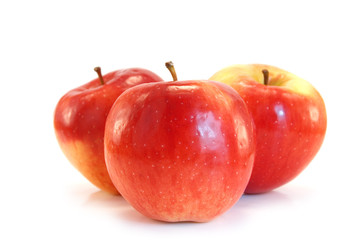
<box><xmin>84</xmin><ymin>186</ymin><xmax>311</xmax><ymax>225</ymax></box>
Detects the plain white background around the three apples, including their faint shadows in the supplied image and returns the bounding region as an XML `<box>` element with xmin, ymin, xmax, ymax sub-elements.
<box><xmin>0</xmin><ymin>0</ymin><xmax>361</xmax><ymax>239</ymax></box>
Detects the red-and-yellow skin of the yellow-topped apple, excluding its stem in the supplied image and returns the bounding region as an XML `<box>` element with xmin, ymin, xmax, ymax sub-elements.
<box><xmin>210</xmin><ymin>64</ymin><xmax>327</xmax><ymax>193</ymax></box>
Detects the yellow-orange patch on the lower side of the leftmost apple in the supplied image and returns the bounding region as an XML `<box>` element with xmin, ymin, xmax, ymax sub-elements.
<box><xmin>59</xmin><ymin>140</ymin><xmax>119</xmax><ymax>194</ymax></box>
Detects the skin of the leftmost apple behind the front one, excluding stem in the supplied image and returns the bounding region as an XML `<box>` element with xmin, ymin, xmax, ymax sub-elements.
<box><xmin>54</xmin><ymin>68</ymin><xmax>162</xmax><ymax>194</ymax></box>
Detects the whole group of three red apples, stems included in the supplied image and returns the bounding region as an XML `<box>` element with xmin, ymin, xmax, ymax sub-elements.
<box><xmin>54</xmin><ymin>62</ymin><xmax>327</xmax><ymax>222</ymax></box>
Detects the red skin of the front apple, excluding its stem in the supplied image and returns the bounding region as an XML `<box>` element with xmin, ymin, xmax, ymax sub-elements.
<box><xmin>105</xmin><ymin>81</ymin><xmax>255</xmax><ymax>222</ymax></box>
